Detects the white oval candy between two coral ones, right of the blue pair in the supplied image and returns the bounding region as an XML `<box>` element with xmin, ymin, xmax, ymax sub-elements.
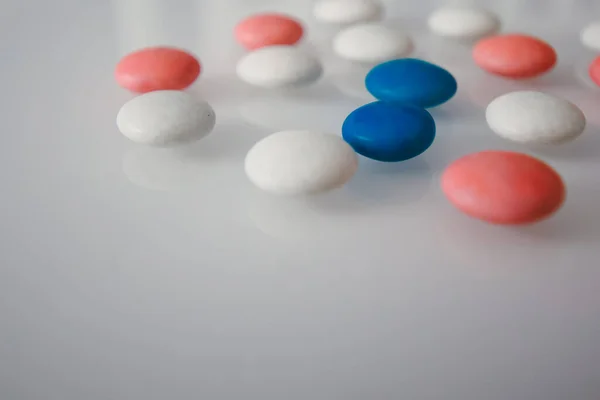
<box><xmin>485</xmin><ymin>91</ymin><xmax>586</xmax><ymax>144</ymax></box>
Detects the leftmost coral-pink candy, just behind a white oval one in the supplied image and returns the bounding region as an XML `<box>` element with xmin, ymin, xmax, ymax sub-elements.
<box><xmin>115</xmin><ymin>47</ymin><xmax>200</xmax><ymax>93</ymax></box>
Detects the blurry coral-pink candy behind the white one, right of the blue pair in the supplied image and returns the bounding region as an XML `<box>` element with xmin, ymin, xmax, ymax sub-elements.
<box><xmin>473</xmin><ymin>35</ymin><xmax>557</xmax><ymax>79</ymax></box>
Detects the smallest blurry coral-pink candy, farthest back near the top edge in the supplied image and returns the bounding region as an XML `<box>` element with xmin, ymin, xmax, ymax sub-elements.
<box><xmin>235</xmin><ymin>14</ymin><xmax>304</xmax><ymax>50</ymax></box>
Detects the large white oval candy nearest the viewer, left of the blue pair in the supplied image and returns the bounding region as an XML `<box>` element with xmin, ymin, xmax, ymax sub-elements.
<box><xmin>245</xmin><ymin>131</ymin><xmax>358</xmax><ymax>195</ymax></box>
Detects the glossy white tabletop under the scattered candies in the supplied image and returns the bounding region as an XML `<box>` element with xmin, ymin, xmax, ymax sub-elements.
<box><xmin>0</xmin><ymin>0</ymin><xmax>600</xmax><ymax>400</ymax></box>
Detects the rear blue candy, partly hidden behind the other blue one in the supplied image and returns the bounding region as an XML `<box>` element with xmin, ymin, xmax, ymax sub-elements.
<box><xmin>365</xmin><ymin>58</ymin><xmax>457</xmax><ymax>108</ymax></box>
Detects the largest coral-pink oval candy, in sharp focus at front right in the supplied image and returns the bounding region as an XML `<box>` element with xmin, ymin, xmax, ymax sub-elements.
<box><xmin>442</xmin><ymin>151</ymin><xmax>565</xmax><ymax>225</ymax></box>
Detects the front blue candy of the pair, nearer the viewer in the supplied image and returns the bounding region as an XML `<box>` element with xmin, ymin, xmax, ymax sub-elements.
<box><xmin>342</xmin><ymin>101</ymin><xmax>435</xmax><ymax>162</ymax></box>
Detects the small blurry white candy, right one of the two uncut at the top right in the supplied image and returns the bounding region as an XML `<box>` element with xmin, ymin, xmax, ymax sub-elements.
<box><xmin>427</xmin><ymin>7</ymin><xmax>500</xmax><ymax>39</ymax></box>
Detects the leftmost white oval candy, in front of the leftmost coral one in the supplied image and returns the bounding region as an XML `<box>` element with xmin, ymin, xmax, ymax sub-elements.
<box><xmin>117</xmin><ymin>90</ymin><xmax>215</xmax><ymax>146</ymax></box>
